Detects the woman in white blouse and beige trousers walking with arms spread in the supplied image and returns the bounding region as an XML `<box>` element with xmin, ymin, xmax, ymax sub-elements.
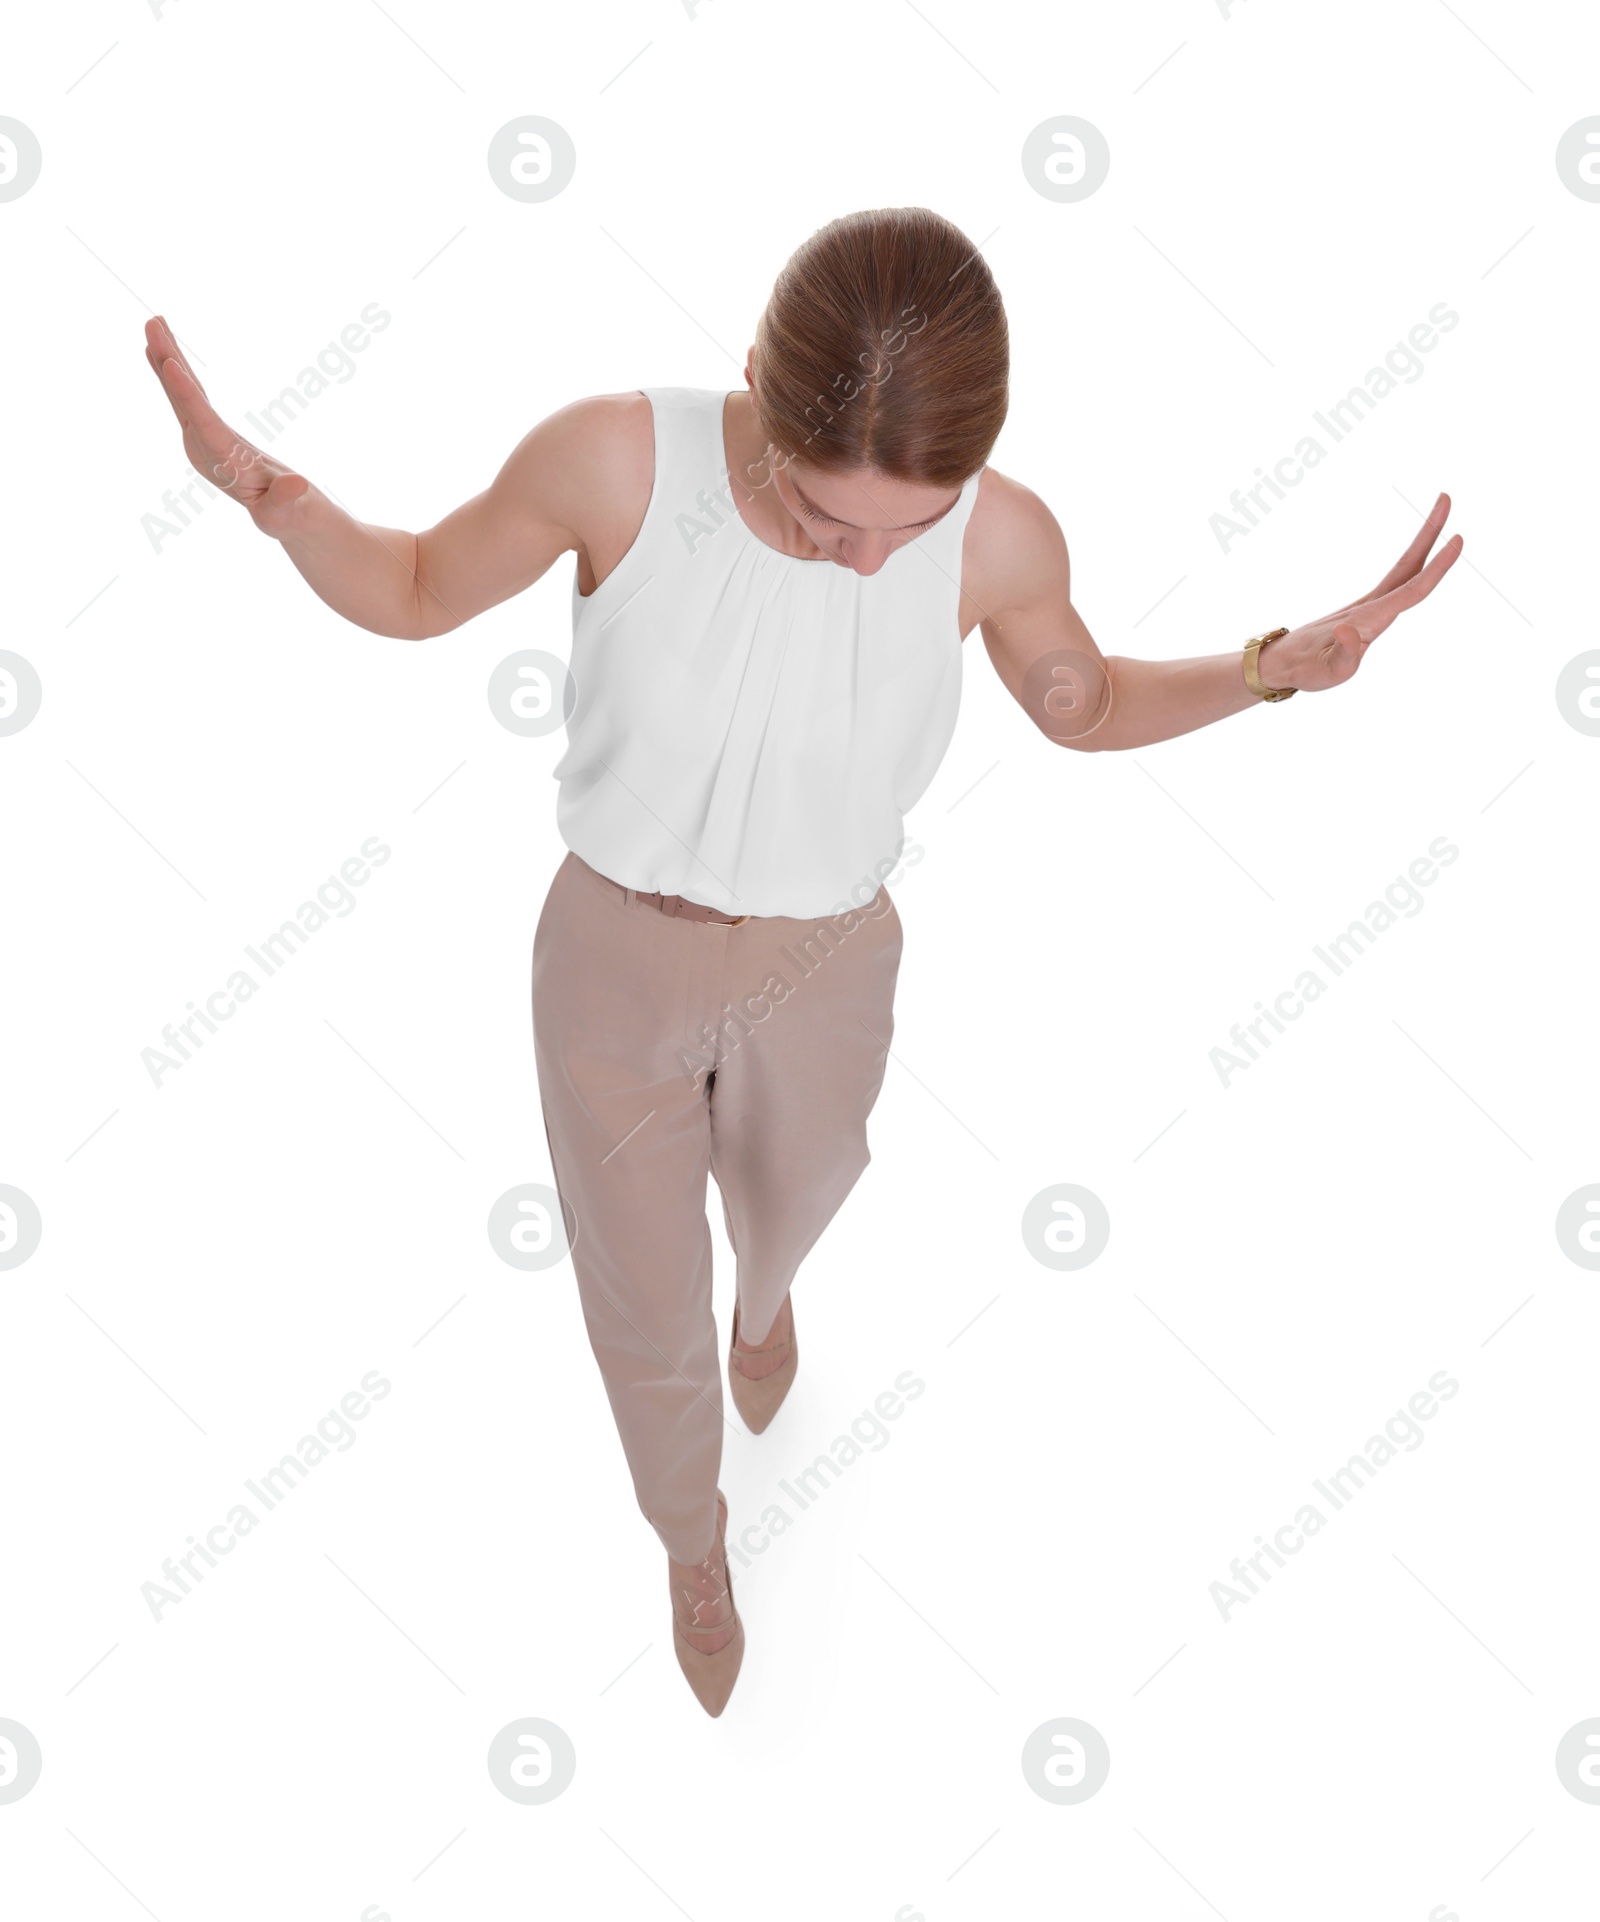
<box><xmin>146</xmin><ymin>208</ymin><xmax>1462</xmax><ymax>1714</ymax></box>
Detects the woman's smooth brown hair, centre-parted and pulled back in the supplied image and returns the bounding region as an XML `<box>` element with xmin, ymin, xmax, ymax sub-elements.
<box><xmin>750</xmin><ymin>208</ymin><xmax>1010</xmax><ymax>486</ymax></box>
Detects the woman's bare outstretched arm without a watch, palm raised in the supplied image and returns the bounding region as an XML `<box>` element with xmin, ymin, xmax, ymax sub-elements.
<box><xmin>144</xmin><ymin>319</ymin><xmax>617</xmax><ymax>640</ymax></box>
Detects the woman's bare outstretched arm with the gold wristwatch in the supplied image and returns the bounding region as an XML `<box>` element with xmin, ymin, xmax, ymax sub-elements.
<box><xmin>981</xmin><ymin>482</ymin><xmax>1462</xmax><ymax>752</ymax></box>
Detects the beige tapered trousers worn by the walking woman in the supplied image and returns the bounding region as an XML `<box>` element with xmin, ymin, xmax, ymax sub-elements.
<box><xmin>533</xmin><ymin>853</ymin><xmax>902</xmax><ymax>1563</ymax></box>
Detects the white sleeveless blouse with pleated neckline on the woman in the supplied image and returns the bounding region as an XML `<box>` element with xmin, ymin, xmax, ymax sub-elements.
<box><xmin>554</xmin><ymin>386</ymin><xmax>979</xmax><ymax>917</ymax></box>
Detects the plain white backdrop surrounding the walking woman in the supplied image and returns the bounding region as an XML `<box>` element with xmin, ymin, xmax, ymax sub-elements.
<box><xmin>0</xmin><ymin>0</ymin><xmax>1600</xmax><ymax>1922</ymax></box>
